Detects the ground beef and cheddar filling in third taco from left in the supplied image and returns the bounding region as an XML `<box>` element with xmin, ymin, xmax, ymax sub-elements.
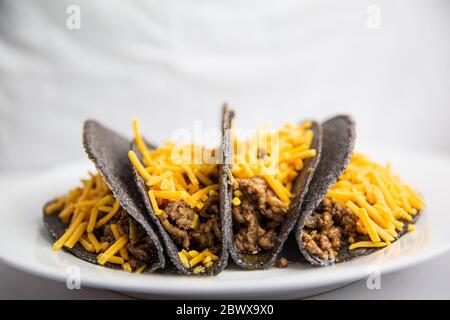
<box><xmin>229</xmin><ymin>121</ymin><xmax>317</xmax><ymax>254</ymax></box>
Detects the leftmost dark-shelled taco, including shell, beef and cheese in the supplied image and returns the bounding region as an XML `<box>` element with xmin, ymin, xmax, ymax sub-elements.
<box><xmin>44</xmin><ymin>121</ymin><xmax>165</xmax><ymax>273</ymax></box>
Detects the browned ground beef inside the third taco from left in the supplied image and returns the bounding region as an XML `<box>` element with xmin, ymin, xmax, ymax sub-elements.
<box><xmin>231</xmin><ymin>176</ymin><xmax>287</xmax><ymax>254</ymax></box>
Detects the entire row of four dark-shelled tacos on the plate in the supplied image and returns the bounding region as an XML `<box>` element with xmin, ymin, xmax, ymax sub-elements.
<box><xmin>44</xmin><ymin>106</ymin><xmax>424</xmax><ymax>275</ymax></box>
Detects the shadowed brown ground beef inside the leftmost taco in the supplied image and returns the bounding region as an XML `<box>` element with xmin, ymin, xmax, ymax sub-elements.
<box><xmin>95</xmin><ymin>209</ymin><xmax>156</xmax><ymax>269</ymax></box>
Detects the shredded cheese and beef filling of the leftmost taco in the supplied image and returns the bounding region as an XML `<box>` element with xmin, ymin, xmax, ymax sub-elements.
<box><xmin>44</xmin><ymin>173</ymin><xmax>155</xmax><ymax>273</ymax></box>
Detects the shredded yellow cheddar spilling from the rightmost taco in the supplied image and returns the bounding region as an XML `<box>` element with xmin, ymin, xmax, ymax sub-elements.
<box><xmin>327</xmin><ymin>153</ymin><xmax>424</xmax><ymax>250</ymax></box>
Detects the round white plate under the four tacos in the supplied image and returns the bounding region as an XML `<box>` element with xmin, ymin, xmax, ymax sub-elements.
<box><xmin>0</xmin><ymin>151</ymin><xmax>450</xmax><ymax>298</ymax></box>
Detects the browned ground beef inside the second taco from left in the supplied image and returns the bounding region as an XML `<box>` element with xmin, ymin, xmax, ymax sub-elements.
<box><xmin>158</xmin><ymin>196</ymin><xmax>222</xmax><ymax>253</ymax></box>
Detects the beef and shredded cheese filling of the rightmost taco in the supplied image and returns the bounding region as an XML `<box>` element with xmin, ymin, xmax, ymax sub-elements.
<box><xmin>302</xmin><ymin>154</ymin><xmax>424</xmax><ymax>262</ymax></box>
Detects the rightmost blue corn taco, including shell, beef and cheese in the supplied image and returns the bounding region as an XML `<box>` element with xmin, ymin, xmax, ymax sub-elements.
<box><xmin>295</xmin><ymin>116</ymin><xmax>424</xmax><ymax>265</ymax></box>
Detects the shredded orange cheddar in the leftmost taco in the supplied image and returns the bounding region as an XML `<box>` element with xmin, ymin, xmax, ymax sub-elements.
<box><xmin>45</xmin><ymin>174</ymin><xmax>145</xmax><ymax>273</ymax></box>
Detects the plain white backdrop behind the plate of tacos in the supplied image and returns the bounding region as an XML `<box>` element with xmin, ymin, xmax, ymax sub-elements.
<box><xmin>0</xmin><ymin>0</ymin><xmax>450</xmax><ymax>298</ymax></box>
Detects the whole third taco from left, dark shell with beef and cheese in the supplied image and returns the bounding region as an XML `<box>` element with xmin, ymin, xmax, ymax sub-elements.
<box><xmin>226</xmin><ymin>108</ymin><xmax>322</xmax><ymax>269</ymax></box>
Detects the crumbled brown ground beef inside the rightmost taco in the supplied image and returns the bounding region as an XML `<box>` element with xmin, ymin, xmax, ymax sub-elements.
<box><xmin>303</xmin><ymin>198</ymin><xmax>367</xmax><ymax>260</ymax></box>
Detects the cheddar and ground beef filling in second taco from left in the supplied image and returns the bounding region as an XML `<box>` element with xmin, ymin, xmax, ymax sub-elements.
<box><xmin>129</xmin><ymin>121</ymin><xmax>222</xmax><ymax>273</ymax></box>
